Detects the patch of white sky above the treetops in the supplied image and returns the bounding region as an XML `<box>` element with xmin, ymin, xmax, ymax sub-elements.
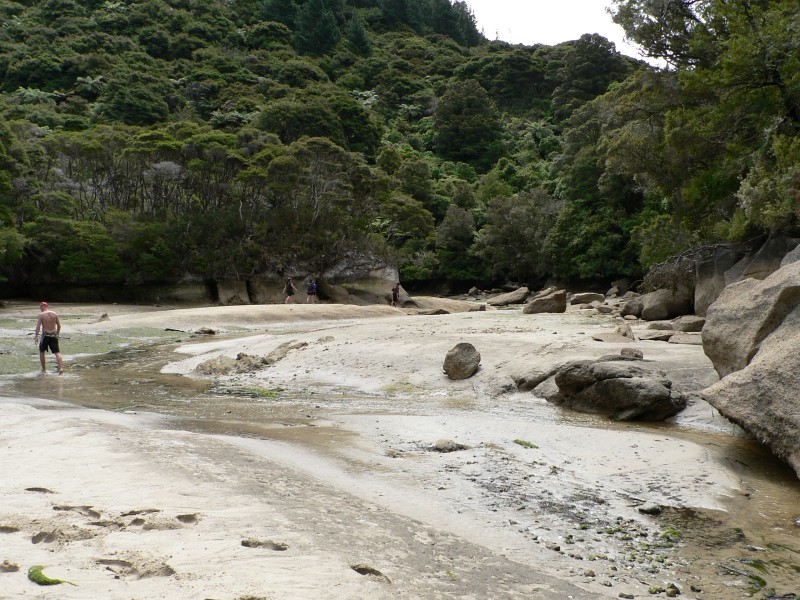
<box><xmin>466</xmin><ymin>0</ymin><xmax>641</xmax><ymax>58</ymax></box>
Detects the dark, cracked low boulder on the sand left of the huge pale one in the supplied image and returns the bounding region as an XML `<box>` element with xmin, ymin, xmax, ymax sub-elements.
<box><xmin>547</xmin><ymin>356</ymin><xmax>686</xmax><ymax>421</ymax></box>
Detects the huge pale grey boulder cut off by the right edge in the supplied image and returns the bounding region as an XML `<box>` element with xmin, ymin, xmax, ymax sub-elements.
<box><xmin>702</xmin><ymin>262</ymin><xmax>800</xmax><ymax>476</ymax></box>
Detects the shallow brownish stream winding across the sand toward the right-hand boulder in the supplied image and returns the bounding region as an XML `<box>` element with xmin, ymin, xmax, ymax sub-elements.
<box><xmin>0</xmin><ymin>341</ymin><xmax>800</xmax><ymax>598</ymax></box>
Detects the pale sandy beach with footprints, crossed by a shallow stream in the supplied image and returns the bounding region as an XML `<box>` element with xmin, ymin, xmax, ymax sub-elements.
<box><xmin>0</xmin><ymin>305</ymin><xmax>800</xmax><ymax>598</ymax></box>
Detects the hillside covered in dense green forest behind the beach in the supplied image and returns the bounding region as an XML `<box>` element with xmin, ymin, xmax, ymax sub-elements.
<box><xmin>0</xmin><ymin>0</ymin><xmax>800</xmax><ymax>294</ymax></box>
